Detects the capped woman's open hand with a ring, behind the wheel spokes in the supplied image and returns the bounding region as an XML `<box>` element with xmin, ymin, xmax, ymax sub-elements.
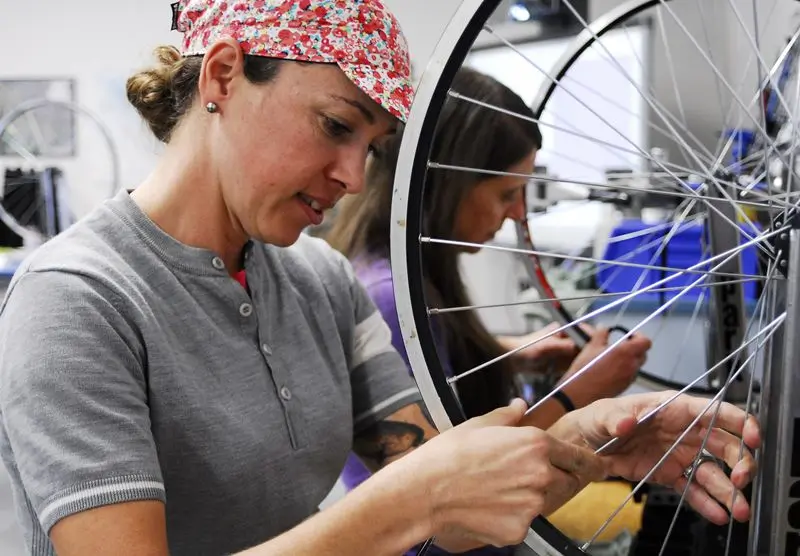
<box><xmin>549</xmin><ymin>392</ymin><xmax>761</xmax><ymax>524</ymax></box>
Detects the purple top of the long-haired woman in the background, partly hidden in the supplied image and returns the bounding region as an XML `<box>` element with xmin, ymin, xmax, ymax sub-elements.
<box><xmin>341</xmin><ymin>258</ymin><xmax>514</xmax><ymax>556</ymax></box>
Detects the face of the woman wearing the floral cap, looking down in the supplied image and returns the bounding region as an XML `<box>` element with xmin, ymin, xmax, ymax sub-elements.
<box><xmin>205</xmin><ymin>46</ymin><xmax>395</xmax><ymax>246</ymax></box>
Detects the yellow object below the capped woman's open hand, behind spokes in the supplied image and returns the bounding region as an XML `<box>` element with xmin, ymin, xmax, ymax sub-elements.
<box><xmin>547</xmin><ymin>481</ymin><xmax>644</xmax><ymax>542</ymax></box>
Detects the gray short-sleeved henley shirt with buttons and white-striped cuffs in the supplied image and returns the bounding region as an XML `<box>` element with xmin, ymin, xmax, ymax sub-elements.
<box><xmin>0</xmin><ymin>192</ymin><xmax>420</xmax><ymax>555</ymax></box>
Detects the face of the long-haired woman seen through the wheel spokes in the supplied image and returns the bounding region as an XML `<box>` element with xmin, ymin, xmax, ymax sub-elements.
<box><xmin>453</xmin><ymin>150</ymin><xmax>536</xmax><ymax>253</ymax></box>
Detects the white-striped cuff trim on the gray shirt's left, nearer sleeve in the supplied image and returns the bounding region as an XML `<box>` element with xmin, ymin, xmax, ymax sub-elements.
<box><xmin>39</xmin><ymin>475</ymin><xmax>166</xmax><ymax>532</ymax></box>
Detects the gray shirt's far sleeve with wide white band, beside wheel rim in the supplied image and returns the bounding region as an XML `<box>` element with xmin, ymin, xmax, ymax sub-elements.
<box><xmin>340</xmin><ymin>263</ymin><xmax>422</xmax><ymax>434</ymax></box>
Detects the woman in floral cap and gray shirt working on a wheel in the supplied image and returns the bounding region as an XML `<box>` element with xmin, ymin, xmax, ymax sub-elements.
<box><xmin>0</xmin><ymin>0</ymin><xmax>758</xmax><ymax>556</ymax></box>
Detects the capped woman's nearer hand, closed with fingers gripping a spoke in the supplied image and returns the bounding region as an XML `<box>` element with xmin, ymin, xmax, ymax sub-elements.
<box><xmin>400</xmin><ymin>400</ymin><xmax>606</xmax><ymax>551</ymax></box>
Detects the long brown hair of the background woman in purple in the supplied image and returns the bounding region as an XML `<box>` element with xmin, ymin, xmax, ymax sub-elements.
<box><xmin>327</xmin><ymin>68</ymin><xmax>542</xmax><ymax>416</ymax></box>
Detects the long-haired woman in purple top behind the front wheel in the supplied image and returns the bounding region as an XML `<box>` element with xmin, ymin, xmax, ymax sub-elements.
<box><xmin>327</xmin><ymin>68</ymin><xmax>650</xmax><ymax>554</ymax></box>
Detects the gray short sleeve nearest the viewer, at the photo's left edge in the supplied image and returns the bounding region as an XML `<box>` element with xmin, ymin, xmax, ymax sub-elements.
<box><xmin>0</xmin><ymin>271</ymin><xmax>165</xmax><ymax>533</ymax></box>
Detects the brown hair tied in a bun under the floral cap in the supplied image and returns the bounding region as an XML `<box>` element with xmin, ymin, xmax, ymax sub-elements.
<box><xmin>126</xmin><ymin>46</ymin><xmax>284</xmax><ymax>143</ymax></box>
